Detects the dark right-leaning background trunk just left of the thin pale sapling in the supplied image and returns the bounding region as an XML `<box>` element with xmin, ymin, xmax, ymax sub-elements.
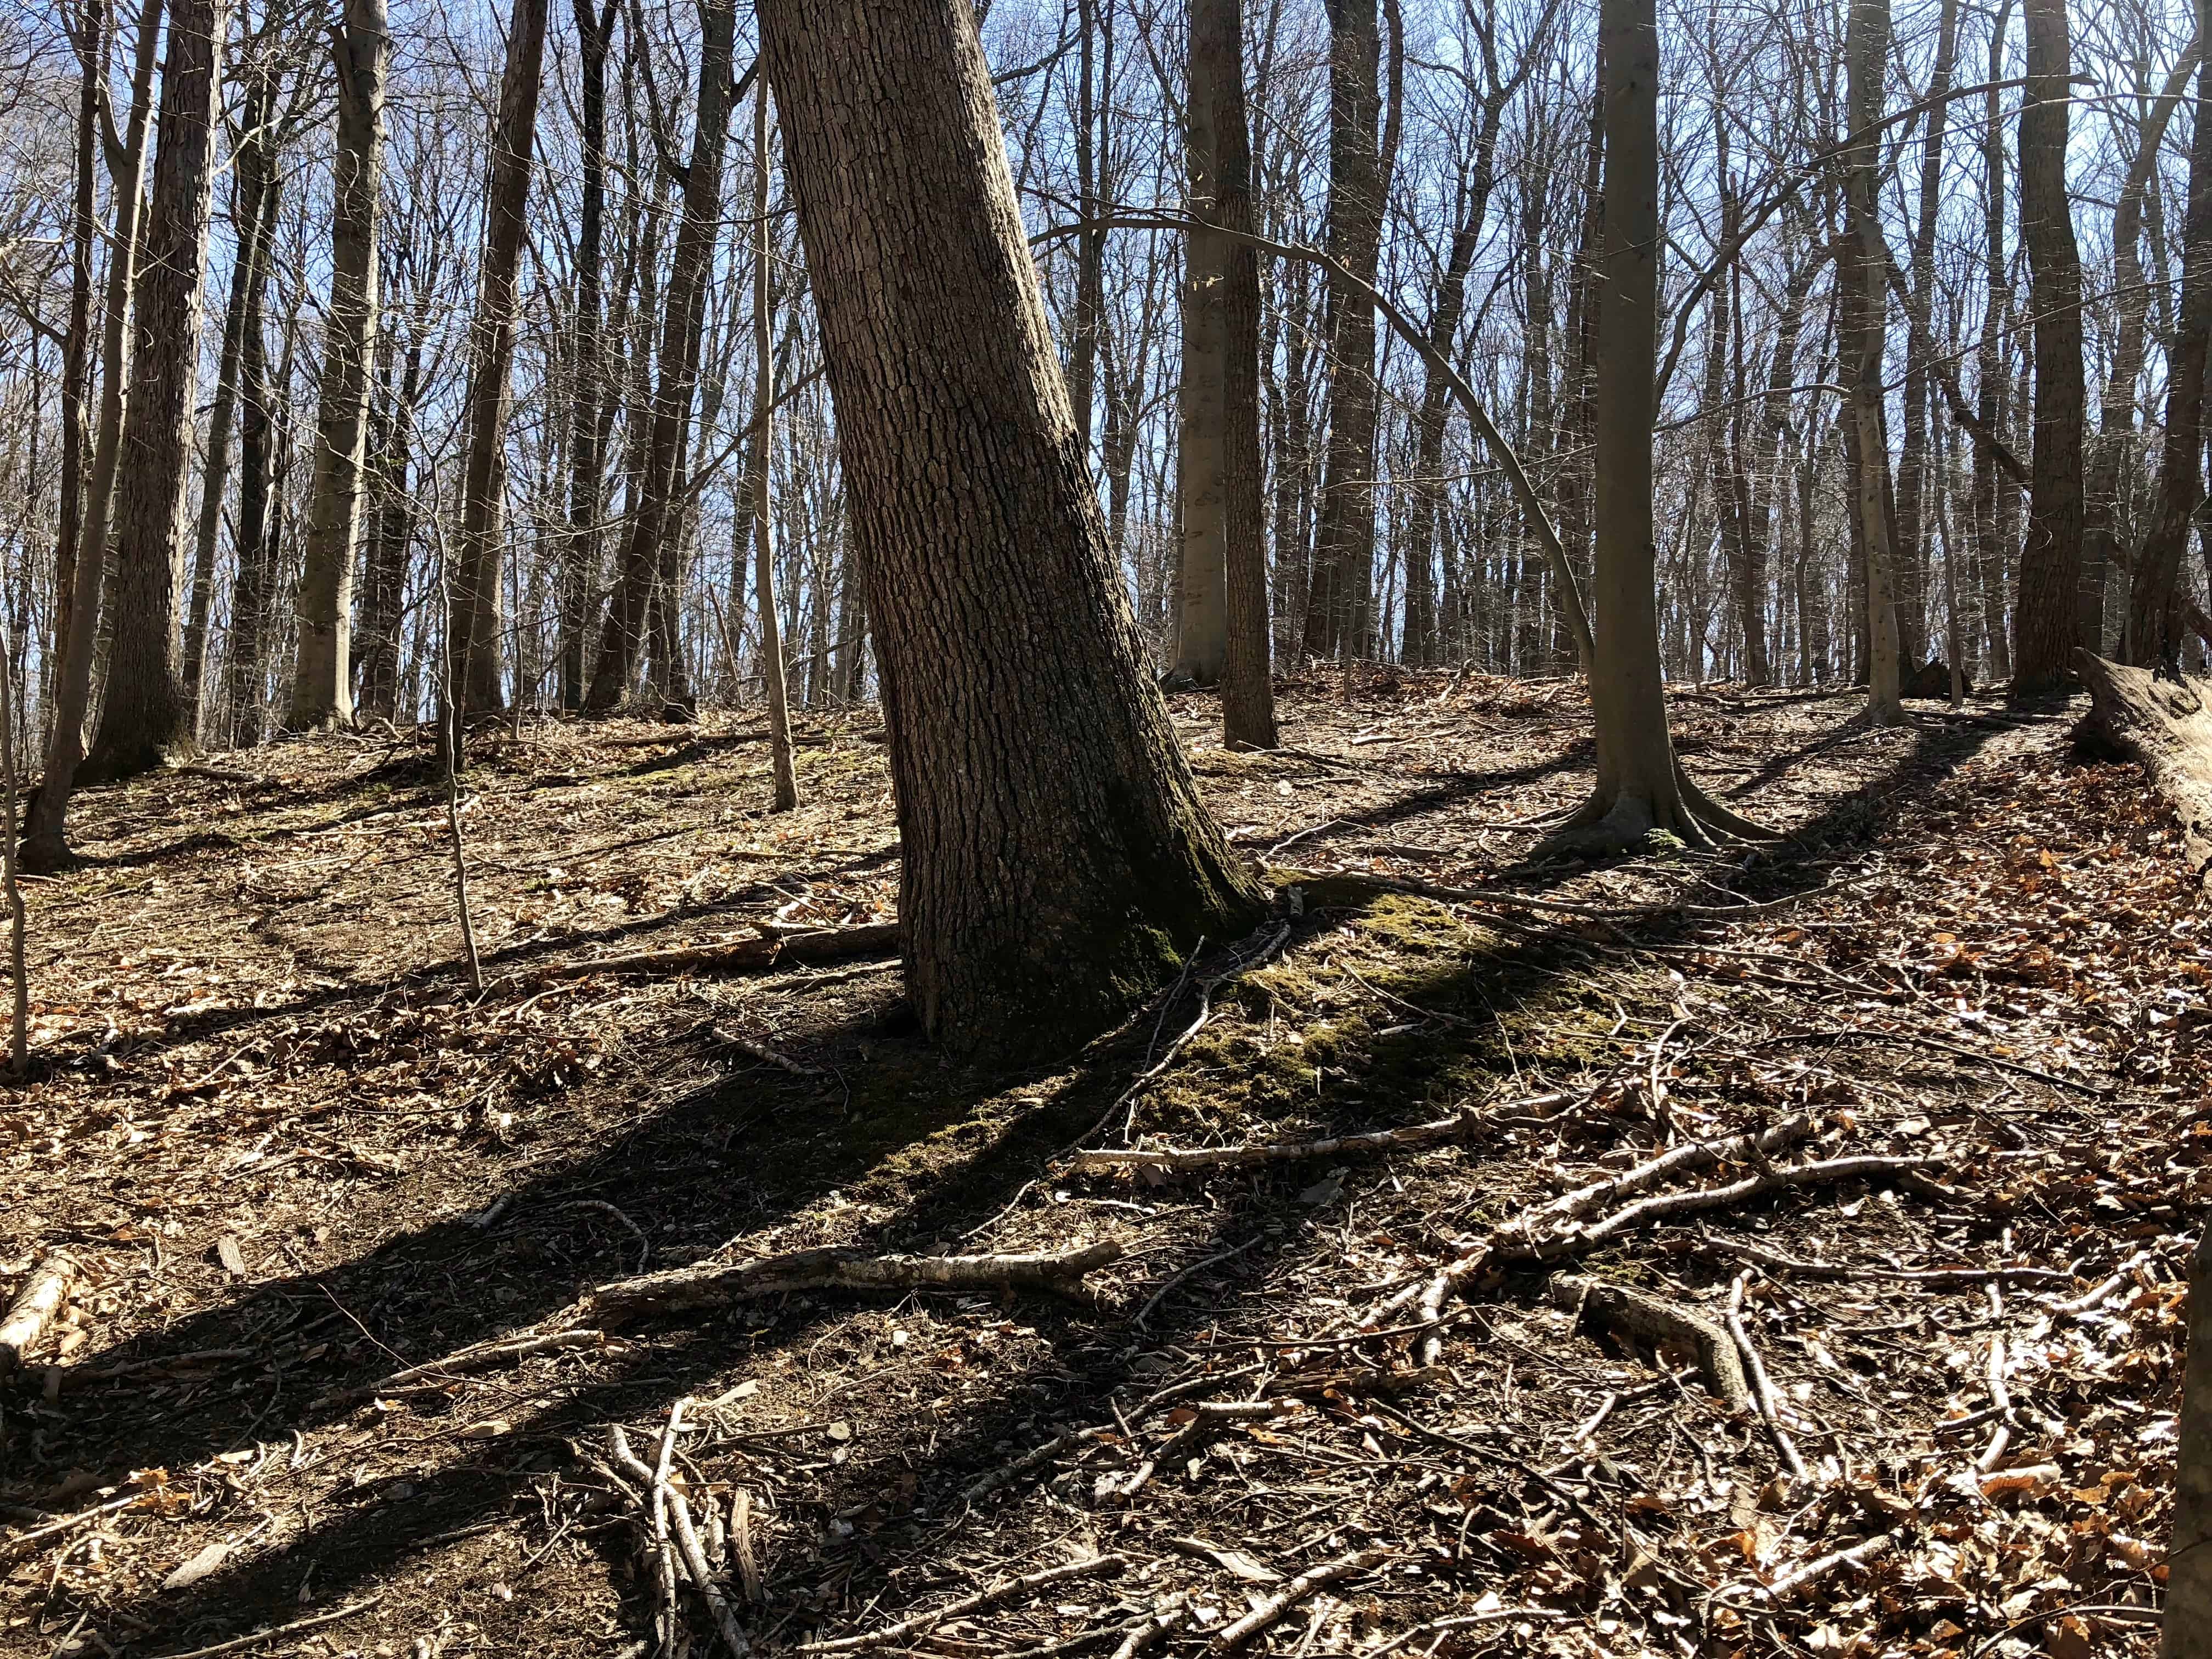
<box><xmin>584</xmin><ymin>0</ymin><xmax>737</xmax><ymax>714</ymax></box>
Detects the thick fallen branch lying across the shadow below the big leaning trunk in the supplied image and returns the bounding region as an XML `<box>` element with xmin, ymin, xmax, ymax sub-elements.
<box><xmin>577</xmin><ymin>1239</ymin><xmax>1121</xmax><ymax>1325</ymax></box>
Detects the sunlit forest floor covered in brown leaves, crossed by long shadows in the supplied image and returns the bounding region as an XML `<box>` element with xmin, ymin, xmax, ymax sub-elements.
<box><xmin>0</xmin><ymin>675</ymin><xmax>2212</xmax><ymax>1659</ymax></box>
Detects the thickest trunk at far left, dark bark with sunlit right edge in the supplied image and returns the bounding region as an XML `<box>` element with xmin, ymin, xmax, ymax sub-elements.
<box><xmin>84</xmin><ymin>0</ymin><xmax>230</xmax><ymax>781</ymax></box>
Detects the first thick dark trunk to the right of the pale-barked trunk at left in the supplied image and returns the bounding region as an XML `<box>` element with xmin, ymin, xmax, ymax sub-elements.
<box><xmin>440</xmin><ymin>0</ymin><xmax>546</xmax><ymax>721</ymax></box>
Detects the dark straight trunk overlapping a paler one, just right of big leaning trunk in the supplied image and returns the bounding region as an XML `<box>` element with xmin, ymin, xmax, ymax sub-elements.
<box><xmin>1190</xmin><ymin>0</ymin><xmax>1276</xmax><ymax>750</ymax></box>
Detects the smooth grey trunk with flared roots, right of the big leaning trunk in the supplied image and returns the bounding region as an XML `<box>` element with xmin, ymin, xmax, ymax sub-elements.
<box><xmin>1548</xmin><ymin>0</ymin><xmax>1765</xmax><ymax>851</ymax></box>
